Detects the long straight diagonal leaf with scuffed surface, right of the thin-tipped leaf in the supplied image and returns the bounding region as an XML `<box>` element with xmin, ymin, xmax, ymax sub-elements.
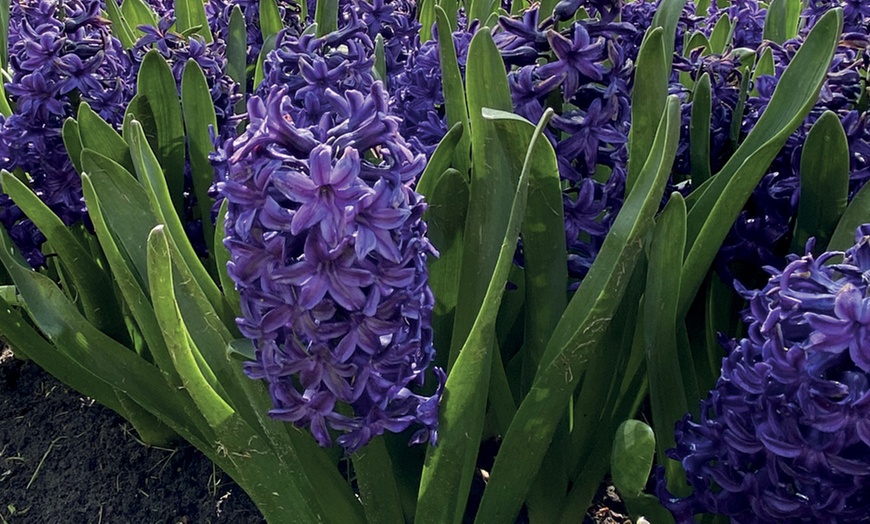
<box><xmin>476</xmin><ymin>97</ymin><xmax>680</xmax><ymax>523</ymax></box>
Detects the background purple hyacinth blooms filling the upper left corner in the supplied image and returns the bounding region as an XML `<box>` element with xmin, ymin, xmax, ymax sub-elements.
<box><xmin>0</xmin><ymin>0</ymin><xmax>238</xmax><ymax>267</ymax></box>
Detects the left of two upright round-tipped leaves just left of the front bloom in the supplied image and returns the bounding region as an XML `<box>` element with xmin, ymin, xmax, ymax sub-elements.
<box><xmin>137</xmin><ymin>50</ymin><xmax>185</xmax><ymax>216</ymax></box>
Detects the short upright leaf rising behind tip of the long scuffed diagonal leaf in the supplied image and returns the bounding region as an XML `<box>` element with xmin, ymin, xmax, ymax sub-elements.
<box><xmin>625</xmin><ymin>28</ymin><xmax>671</xmax><ymax>195</ymax></box>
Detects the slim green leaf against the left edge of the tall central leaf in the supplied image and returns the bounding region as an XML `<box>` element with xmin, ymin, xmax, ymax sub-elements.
<box><xmin>435</xmin><ymin>6</ymin><xmax>471</xmax><ymax>176</ymax></box>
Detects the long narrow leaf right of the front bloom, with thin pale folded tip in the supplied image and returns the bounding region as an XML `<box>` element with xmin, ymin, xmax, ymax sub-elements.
<box><xmin>415</xmin><ymin>110</ymin><xmax>553</xmax><ymax>524</ymax></box>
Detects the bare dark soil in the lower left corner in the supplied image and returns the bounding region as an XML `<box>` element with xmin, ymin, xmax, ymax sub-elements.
<box><xmin>0</xmin><ymin>350</ymin><xmax>263</xmax><ymax>524</ymax></box>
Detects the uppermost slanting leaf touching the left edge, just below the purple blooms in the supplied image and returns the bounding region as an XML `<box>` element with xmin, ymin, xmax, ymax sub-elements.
<box><xmin>0</xmin><ymin>171</ymin><xmax>130</xmax><ymax>344</ymax></box>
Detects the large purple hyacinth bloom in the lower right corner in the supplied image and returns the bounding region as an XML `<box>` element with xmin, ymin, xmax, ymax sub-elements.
<box><xmin>658</xmin><ymin>225</ymin><xmax>870</xmax><ymax>522</ymax></box>
